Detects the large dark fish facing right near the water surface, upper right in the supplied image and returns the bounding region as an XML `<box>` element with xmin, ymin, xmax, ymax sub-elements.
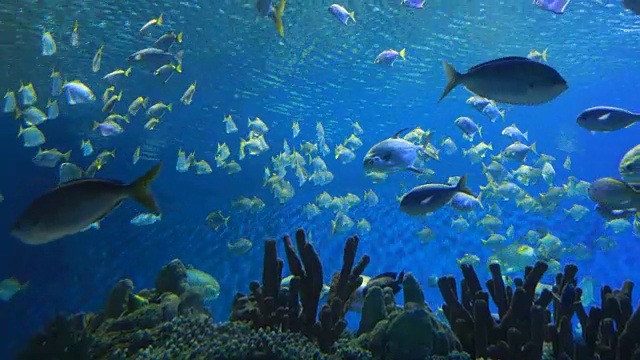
<box><xmin>438</xmin><ymin>56</ymin><xmax>569</xmax><ymax>105</ymax></box>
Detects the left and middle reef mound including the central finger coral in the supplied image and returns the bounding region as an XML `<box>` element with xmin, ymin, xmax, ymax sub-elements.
<box><xmin>17</xmin><ymin>230</ymin><xmax>469</xmax><ymax>360</ymax></box>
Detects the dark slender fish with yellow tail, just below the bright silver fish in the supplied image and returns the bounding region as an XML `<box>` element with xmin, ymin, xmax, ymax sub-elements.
<box><xmin>400</xmin><ymin>175</ymin><xmax>475</xmax><ymax>216</ymax></box>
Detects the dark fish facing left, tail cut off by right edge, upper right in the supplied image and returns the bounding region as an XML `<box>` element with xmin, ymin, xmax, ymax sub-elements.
<box><xmin>576</xmin><ymin>106</ymin><xmax>640</xmax><ymax>132</ymax></box>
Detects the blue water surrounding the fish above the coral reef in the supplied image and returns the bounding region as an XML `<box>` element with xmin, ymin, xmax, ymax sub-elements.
<box><xmin>0</xmin><ymin>0</ymin><xmax>640</xmax><ymax>354</ymax></box>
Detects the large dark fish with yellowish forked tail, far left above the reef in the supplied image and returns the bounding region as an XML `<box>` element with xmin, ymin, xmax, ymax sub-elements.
<box><xmin>11</xmin><ymin>164</ymin><xmax>162</xmax><ymax>245</ymax></box>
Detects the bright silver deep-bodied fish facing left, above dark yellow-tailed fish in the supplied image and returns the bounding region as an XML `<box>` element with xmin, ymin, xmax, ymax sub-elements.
<box><xmin>362</xmin><ymin>128</ymin><xmax>437</xmax><ymax>174</ymax></box>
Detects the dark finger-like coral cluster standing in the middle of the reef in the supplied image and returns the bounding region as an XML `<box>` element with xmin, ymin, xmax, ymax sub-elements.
<box><xmin>230</xmin><ymin>229</ymin><xmax>369</xmax><ymax>353</ymax></box>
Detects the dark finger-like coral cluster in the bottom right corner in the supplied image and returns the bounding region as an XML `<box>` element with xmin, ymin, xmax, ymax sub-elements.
<box><xmin>438</xmin><ymin>262</ymin><xmax>640</xmax><ymax>360</ymax></box>
